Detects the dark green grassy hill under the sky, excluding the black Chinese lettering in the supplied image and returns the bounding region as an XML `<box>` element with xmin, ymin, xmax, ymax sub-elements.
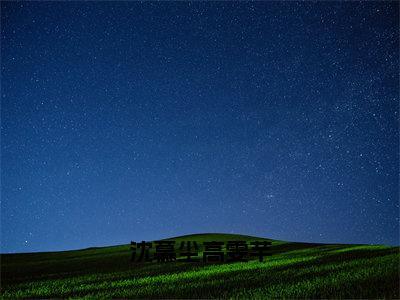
<box><xmin>1</xmin><ymin>234</ymin><xmax>400</xmax><ymax>299</ymax></box>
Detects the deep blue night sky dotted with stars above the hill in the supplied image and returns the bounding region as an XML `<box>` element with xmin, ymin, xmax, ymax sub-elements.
<box><xmin>1</xmin><ymin>1</ymin><xmax>399</xmax><ymax>252</ymax></box>
